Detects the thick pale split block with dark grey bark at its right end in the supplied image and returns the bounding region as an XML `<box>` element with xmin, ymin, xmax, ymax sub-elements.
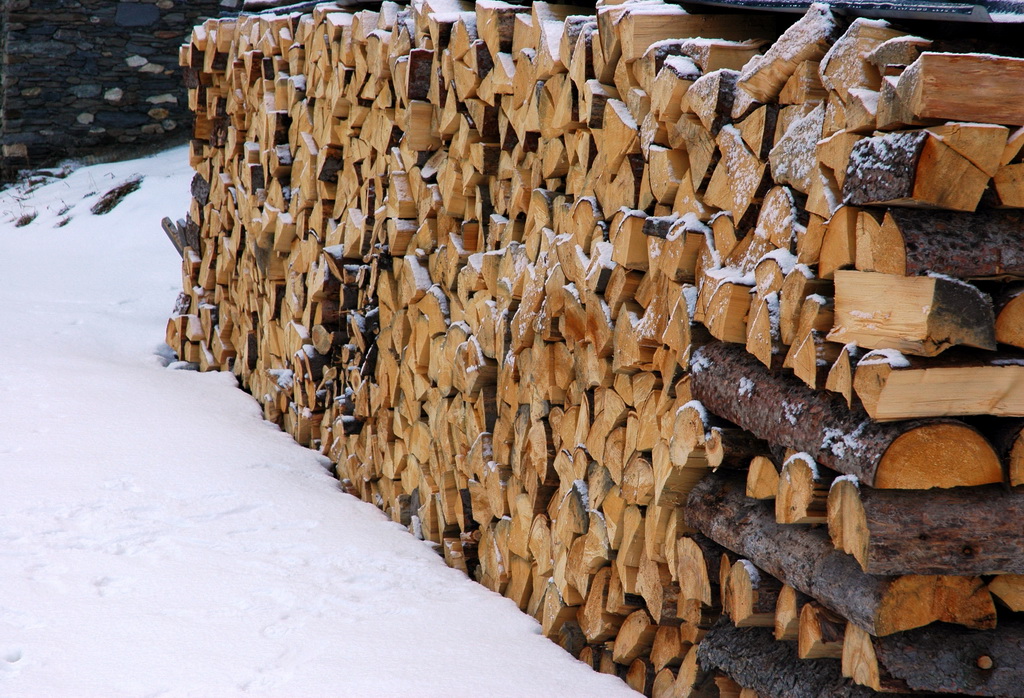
<box><xmin>828</xmin><ymin>271</ymin><xmax>995</xmax><ymax>356</ymax></box>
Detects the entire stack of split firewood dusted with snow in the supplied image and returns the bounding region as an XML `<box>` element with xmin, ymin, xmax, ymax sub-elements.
<box><xmin>168</xmin><ymin>0</ymin><xmax>1024</xmax><ymax>697</ymax></box>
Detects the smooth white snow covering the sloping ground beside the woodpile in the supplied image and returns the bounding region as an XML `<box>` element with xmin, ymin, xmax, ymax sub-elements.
<box><xmin>0</xmin><ymin>148</ymin><xmax>636</xmax><ymax>698</ymax></box>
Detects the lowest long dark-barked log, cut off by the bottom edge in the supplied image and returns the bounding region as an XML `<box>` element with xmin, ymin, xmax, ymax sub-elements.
<box><xmin>697</xmin><ymin>618</ymin><xmax>913</xmax><ymax>698</ymax></box>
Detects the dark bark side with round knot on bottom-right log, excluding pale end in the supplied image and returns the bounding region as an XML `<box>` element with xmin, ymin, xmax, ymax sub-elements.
<box><xmin>871</xmin><ymin>621</ymin><xmax>1024</xmax><ymax>698</ymax></box>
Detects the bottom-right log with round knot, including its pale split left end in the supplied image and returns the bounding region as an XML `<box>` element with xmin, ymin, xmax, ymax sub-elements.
<box><xmin>843</xmin><ymin>622</ymin><xmax>1024</xmax><ymax>696</ymax></box>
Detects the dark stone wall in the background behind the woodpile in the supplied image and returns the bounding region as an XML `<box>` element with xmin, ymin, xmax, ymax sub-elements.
<box><xmin>0</xmin><ymin>0</ymin><xmax>226</xmax><ymax>181</ymax></box>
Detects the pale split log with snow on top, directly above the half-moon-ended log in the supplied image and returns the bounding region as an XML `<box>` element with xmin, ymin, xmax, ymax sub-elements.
<box><xmin>853</xmin><ymin>349</ymin><xmax>1024</xmax><ymax>422</ymax></box>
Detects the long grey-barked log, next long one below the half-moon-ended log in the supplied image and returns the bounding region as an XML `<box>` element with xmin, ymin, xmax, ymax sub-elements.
<box><xmin>686</xmin><ymin>474</ymin><xmax>995</xmax><ymax>636</ymax></box>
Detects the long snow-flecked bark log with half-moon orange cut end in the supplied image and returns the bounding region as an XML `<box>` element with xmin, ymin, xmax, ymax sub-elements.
<box><xmin>690</xmin><ymin>342</ymin><xmax>1001</xmax><ymax>489</ymax></box>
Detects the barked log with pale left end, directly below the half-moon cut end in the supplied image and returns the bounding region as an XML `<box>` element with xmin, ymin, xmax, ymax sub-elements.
<box><xmin>828</xmin><ymin>480</ymin><xmax>1024</xmax><ymax>574</ymax></box>
